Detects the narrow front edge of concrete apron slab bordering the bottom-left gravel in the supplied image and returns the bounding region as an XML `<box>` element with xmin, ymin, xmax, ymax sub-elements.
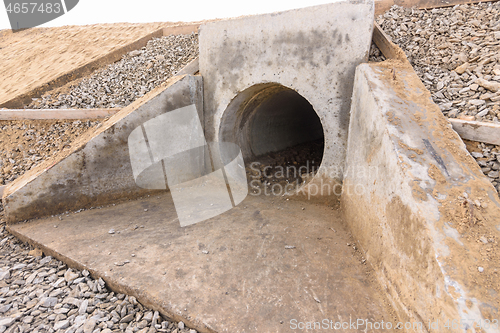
<box><xmin>6</xmin><ymin>225</ymin><xmax>217</xmax><ymax>333</ymax></box>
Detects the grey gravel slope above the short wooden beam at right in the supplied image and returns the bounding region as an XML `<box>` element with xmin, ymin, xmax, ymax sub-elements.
<box><xmin>377</xmin><ymin>2</ymin><xmax>500</xmax><ymax>122</ymax></box>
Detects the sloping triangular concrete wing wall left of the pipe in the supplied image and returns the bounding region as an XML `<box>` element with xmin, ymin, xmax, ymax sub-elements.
<box><xmin>3</xmin><ymin>75</ymin><xmax>203</xmax><ymax>223</ymax></box>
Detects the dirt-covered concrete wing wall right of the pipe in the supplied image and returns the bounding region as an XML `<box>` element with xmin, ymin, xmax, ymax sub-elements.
<box><xmin>341</xmin><ymin>61</ymin><xmax>500</xmax><ymax>332</ymax></box>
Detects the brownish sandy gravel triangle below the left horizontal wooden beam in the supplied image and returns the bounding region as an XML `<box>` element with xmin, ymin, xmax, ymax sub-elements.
<box><xmin>0</xmin><ymin>120</ymin><xmax>100</xmax><ymax>185</ymax></box>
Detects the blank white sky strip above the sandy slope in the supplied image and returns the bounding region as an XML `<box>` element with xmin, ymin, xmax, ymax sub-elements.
<box><xmin>0</xmin><ymin>0</ymin><xmax>336</xmax><ymax>29</ymax></box>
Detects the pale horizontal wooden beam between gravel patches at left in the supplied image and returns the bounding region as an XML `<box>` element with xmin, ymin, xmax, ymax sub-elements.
<box><xmin>0</xmin><ymin>108</ymin><xmax>121</xmax><ymax>120</ymax></box>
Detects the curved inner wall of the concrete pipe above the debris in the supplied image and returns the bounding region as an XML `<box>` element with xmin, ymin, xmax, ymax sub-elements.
<box><xmin>219</xmin><ymin>83</ymin><xmax>324</xmax><ymax>166</ymax></box>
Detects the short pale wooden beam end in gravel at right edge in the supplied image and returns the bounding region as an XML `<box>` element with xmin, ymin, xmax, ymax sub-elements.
<box><xmin>448</xmin><ymin>118</ymin><xmax>500</xmax><ymax>145</ymax></box>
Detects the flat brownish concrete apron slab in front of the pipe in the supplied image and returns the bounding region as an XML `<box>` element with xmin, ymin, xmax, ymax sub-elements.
<box><xmin>8</xmin><ymin>193</ymin><xmax>395</xmax><ymax>333</ymax></box>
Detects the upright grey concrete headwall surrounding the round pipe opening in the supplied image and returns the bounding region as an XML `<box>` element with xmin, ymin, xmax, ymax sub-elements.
<box><xmin>199</xmin><ymin>1</ymin><xmax>374</xmax><ymax>178</ymax></box>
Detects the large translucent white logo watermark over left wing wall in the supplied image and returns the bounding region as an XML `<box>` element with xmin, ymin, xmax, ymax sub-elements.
<box><xmin>128</xmin><ymin>105</ymin><xmax>248</xmax><ymax>227</ymax></box>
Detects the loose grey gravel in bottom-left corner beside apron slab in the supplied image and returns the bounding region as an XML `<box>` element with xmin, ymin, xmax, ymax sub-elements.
<box><xmin>0</xmin><ymin>216</ymin><xmax>196</xmax><ymax>333</ymax></box>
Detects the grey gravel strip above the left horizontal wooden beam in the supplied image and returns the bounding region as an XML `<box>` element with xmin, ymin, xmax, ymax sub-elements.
<box><xmin>28</xmin><ymin>33</ymin><xmax>198</xmax><ymax>109</ymax></box>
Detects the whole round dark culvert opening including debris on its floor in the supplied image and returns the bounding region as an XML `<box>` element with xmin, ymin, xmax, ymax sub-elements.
<box><xmin>219</xmin><ymin>83</ymin><xmax>324</xmax><ymax>192</ymax></box>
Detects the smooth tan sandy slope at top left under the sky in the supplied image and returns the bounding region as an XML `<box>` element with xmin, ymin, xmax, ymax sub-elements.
<box><xmin>0</xmin><ymin>23</ymin><xmax>169</xmax><ymax>104</ymax></box>
